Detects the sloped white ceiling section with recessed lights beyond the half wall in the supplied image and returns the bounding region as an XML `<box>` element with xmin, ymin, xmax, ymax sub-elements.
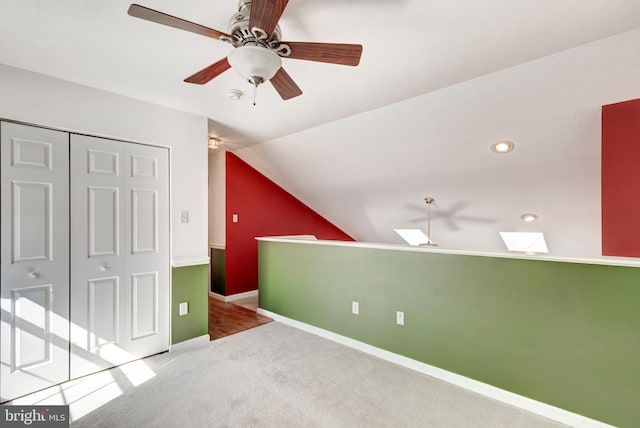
<box><xmin>236</xmin><ymin>30</ymin><xmax>640</xmax><ymax>257</ymax></box>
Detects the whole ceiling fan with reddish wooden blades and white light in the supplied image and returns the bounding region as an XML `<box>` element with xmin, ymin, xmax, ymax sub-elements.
<box><xmin>127</xmin><ymin>0</ymin><xmax>362</xmax><ymax>104</ymax></box>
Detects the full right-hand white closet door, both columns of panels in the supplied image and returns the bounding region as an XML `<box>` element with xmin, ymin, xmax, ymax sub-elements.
<box><xmin>70</xmin><ymin>135</ymin><xmax>170</xmax><ymax>378</ymax></box>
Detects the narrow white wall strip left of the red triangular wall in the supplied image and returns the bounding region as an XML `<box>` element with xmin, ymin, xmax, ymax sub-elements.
<box><xmin>209</xmin><ymin>149</ymin><xmax>226</xmax><ymax>247</ymax></box>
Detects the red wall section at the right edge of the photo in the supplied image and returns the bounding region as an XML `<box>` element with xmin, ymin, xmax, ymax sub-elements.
<box><xmin>602</xmin><ymin>99</ymin><xmax>640</xmax><ymax>257</ymax></box>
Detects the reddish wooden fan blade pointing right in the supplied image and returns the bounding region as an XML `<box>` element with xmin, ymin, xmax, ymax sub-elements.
<box><xmin>282</xmin><ymin>42</ymin><xmax>362</xmax><ymax>66</ymax></box>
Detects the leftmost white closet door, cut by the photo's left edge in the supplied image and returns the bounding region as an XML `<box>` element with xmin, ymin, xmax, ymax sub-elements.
<box><xmin>0</xmin><ymin>122</ymin><xmax>69</xmax><ymax>401</ymax></box>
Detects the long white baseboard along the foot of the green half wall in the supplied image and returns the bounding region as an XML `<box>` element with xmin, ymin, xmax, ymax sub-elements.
<box><xmin>258</xmin><ymin>308</ymin><xmax>615</xmax><ymax>428</ymax></box>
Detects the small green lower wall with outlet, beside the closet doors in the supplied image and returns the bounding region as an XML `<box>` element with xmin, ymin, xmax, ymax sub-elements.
<box><xmin>171</xmin><ymin>265</ymin><xmax>209</xmax><ymax>344</ymax></box>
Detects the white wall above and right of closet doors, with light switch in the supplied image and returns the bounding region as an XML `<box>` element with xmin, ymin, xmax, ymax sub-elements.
<box><xmin>0</xmin><ymin>64</ymin><xmax>208</xmax><ymax>262</ymax></box>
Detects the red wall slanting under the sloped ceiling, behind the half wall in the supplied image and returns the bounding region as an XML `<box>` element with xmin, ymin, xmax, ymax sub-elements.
<box><xmin>225</xmin><ymin>152</ymin><xmax>354</xmax><ymax>295</ymax></box>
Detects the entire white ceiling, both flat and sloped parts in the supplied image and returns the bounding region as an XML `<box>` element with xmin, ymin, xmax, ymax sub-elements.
<box><xmin>0</xmin><ymin>0</ymin><xmax>640</xmax><ymax>256</ymax></box>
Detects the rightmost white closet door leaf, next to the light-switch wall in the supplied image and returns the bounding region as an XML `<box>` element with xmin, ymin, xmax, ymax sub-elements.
<box><xmin>124</xmin><ymin>144</ymin><xmax>170</xmax><ymax>355</ymax></box>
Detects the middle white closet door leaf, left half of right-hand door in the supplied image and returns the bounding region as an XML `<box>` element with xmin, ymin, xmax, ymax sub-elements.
<box><xmin>70</xmin><ymin>135</ymin><xmax>125</xmax><ymax>378</ymax></box>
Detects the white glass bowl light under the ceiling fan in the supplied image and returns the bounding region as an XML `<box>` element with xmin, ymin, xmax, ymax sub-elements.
<box><xmin>228</xmin><ymin>46</ymin><xmax>282</xmax><ymax>86</ymax></box>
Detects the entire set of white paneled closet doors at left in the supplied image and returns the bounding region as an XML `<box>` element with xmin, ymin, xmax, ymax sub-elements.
<box><xmin>0</xmin><ymin>122</ymin><xmax>170</xmax><ymax>402</ymax></box>
